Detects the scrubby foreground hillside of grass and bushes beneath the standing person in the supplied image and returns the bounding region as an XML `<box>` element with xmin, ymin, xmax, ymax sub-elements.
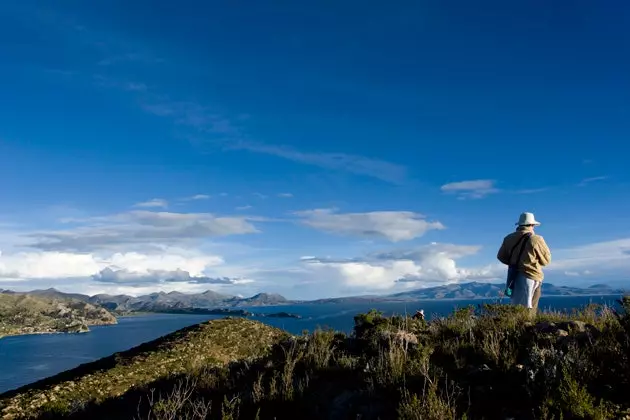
<box><xmin>0</xmin><ymin>297</ymin><xmax>630</xmax><ymax>420</ymax></box>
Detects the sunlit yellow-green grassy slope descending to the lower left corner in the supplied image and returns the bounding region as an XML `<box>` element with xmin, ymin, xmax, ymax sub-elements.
<box><xmin>0</xmin><ymin>318</ymin><xmax>287</xmax><ymax>418</ymax></box>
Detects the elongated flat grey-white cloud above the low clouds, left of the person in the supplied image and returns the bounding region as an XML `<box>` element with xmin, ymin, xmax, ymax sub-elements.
<box><xmin>295</xmin><ymin>209</ymin><xmax>445</xmax><ymax>242</ymax></box>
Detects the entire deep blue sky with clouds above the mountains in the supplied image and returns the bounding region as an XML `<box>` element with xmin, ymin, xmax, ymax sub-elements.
<box><xmin>0</xmin><ymin>0</ymin><xmax>630</xmax><ymax>298</ymax></box>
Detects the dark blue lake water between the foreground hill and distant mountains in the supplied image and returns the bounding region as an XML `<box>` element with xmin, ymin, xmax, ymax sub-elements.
<box><xmin>0</xmin><ymin>296</ymin><xmax>618</xmax><ymax>393</ymax></box>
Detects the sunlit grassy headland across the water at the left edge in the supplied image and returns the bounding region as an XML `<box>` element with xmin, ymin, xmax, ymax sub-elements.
<box><xmin>0</xmin><ymin>293</ymin><xmax>116</xmax><ymax>337</ymax></box>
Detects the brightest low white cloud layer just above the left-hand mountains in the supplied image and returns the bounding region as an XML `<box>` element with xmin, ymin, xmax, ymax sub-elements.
<box><xmin>0</xmin><ymin>244</ymin><xmax>254</xmax><ymax>295</ymax></box>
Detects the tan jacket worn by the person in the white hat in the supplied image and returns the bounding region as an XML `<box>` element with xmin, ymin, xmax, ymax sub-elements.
<box><xmin>497</xmin><ymin>230</ymin><xmax>551</xmax><ymax>281</ymax></box>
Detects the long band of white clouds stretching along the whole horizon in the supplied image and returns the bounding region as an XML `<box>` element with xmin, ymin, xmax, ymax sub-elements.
<box><xmin>0</xmin><ymin>204</ymin><xmax>630</xmax><ymax>298</ymax></box>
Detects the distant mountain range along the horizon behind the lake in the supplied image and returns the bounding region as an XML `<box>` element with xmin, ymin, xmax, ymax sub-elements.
<box><xmin>0</xmin><ymin>282</ymin><xmax>625</xmax><ymax>314</ymax></box>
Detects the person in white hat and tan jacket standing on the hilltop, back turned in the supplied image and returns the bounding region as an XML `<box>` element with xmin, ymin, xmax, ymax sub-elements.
<box><xmin>497</xmin><ymin>212</ymin><xmax>551</xmax><ymax>314</ymax></box>
